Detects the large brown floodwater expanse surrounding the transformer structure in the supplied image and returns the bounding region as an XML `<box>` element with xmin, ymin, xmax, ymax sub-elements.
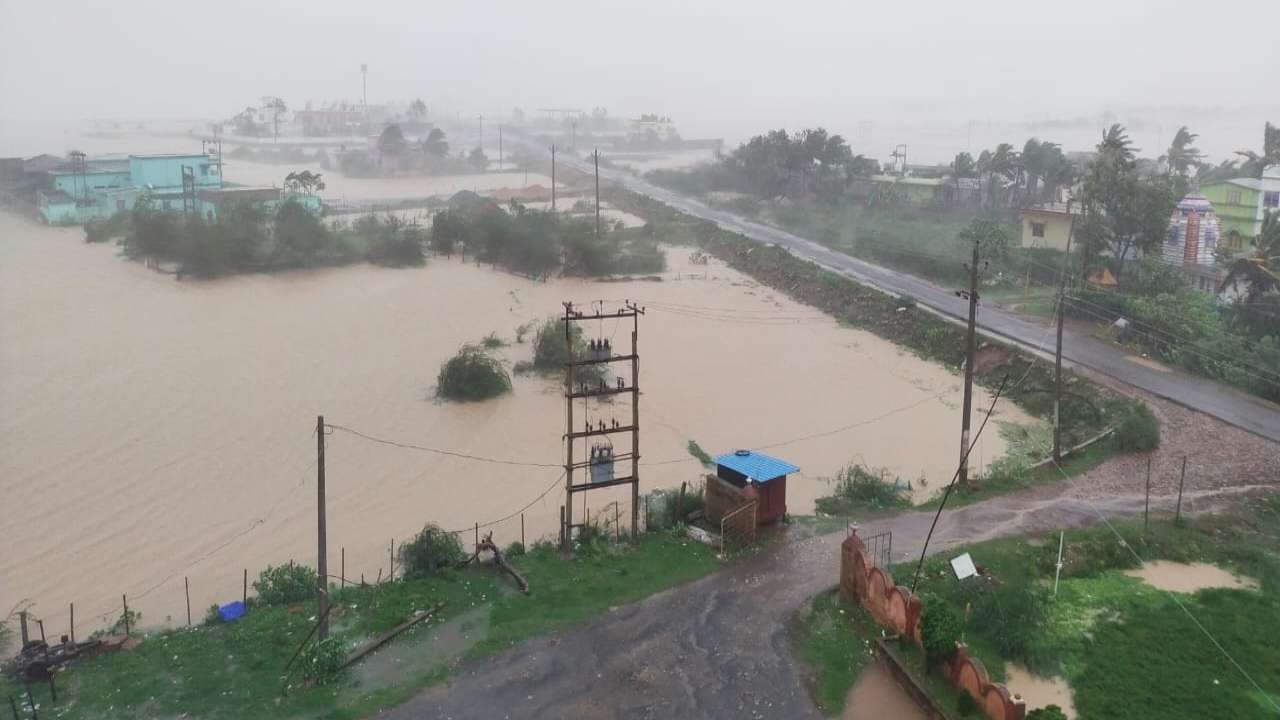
<box><xmin>0</xmin><ymin>214</ymin><xmax>1027</xmax><ymax>637</ymax></box>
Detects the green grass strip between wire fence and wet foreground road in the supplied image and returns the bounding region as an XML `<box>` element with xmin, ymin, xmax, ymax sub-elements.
<box><xmin>0</xmin><ymin>533</ymin><xmax>719</xmax><ymax>720</ymax></box>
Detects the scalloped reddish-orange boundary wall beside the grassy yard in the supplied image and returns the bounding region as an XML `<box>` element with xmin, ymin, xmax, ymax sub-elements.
<box><xmin>840</xmin><ymin>530</ymin><xmax>1027</xmax><ymax>720</ymax></box>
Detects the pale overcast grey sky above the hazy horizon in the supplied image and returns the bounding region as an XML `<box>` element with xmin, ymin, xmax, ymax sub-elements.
<box><xmin>0</xmin><ymin>0</ymin><xmax>1280</xmax><ymax>162</ymax></box>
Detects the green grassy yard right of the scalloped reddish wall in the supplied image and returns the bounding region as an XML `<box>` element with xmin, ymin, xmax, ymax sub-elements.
<box><xmin>895</xmin><ymin>496</ymin><xmax>1280</xmax><ymax>720</ymax></box>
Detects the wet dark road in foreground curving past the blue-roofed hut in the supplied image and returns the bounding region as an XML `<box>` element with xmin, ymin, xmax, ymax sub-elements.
<box><xmin>378</xmin><ymin>486</ymin><xmax>1239</xmax><ymax>720</ymax></box>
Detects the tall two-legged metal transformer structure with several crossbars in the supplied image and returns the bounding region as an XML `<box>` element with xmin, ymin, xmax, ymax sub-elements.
<box><xmin>561</xmin><ymin>301</ymin><xmax>644</xmax><ymax>552</ymax></box>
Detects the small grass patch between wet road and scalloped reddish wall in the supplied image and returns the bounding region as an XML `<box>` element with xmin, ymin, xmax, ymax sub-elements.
<box><xmin>792</xmin><ymin>588</ymin><xmax>881</xmax><ymax>715</ymax></box>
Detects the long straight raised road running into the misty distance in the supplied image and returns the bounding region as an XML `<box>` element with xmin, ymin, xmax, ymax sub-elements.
<box><xmin>527</xmin><ymin>139</ymin><xmax>1280</xmax><ymax>442</ymax></box>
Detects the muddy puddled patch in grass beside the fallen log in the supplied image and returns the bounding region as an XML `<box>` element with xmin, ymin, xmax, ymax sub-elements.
<box><xmin>355</xmin><ymin>607</ymin><xmax>489</xmax><ymax>691</ymax></box>
